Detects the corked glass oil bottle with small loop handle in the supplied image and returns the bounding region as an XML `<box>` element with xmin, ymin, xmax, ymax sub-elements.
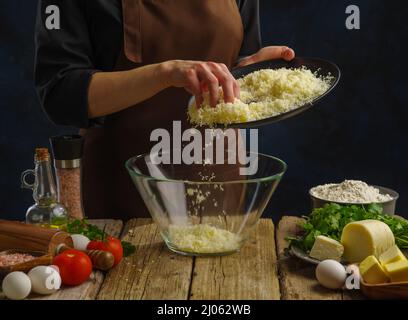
<box><xmin>21</xmin><ymin>148</ymin><xmax>68</xmax><ymax>228</ymax></box>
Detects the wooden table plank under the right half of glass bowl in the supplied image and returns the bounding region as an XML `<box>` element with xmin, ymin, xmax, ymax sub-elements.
<box><xmin>190</xmin><ymin>219</ymin><xmax>280</xmax><ymax>300</ymax></box>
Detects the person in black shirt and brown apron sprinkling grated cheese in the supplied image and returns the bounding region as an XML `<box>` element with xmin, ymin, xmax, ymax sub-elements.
<box><xmin>35</xmin><ymin>0</ymin><xmax>295</xmax><ymax>219</ymax></box>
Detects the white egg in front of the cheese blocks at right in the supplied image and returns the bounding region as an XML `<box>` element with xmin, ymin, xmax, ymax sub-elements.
<box><xmin>316</xmin><ymin>260</ymin><xmax>347</xmax><ymax>289</ymax></box>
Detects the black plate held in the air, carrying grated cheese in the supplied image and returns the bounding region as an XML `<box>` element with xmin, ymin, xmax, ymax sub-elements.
<box><xmin>219</xmin><ymin>58</ymin><xmax>341</xmax><ymax>128</ymax></box>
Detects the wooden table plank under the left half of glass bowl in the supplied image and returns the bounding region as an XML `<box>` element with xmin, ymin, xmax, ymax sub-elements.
<box><xmin>97</xmin><ymin>219</ymin><xmax>193</xmax><ymax>300</ymax></box>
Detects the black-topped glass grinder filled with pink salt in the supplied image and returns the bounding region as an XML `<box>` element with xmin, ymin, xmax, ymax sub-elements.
<box><xmin>50</xmin><ymin>135</ymin><xmax>85</xmax><ymax>219</ymax></box>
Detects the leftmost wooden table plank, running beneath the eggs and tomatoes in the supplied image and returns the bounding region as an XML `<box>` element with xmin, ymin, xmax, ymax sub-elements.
<box><xmin>30</xmin><ymin>220</ymin><xmax>123</xmax><ymax>300</ymax></box>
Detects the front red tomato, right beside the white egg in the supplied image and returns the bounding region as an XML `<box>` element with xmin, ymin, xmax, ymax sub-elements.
<box><xmin>53</xmin><ymin>249</ymin><xmax>92</xmax><ymax>286</ymax></box>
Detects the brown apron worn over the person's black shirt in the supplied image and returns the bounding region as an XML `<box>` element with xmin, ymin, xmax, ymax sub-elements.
<box><xmin>82</xmin><ymin>0</ymin><xmax>243</xmax><ymax>220</ymax></box>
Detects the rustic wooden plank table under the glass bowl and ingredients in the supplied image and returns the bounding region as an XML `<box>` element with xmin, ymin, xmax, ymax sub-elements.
<box><xmin>0</xmin><ymin>217</ymin><xmax>362</xmax><ymax>300</ymax></box>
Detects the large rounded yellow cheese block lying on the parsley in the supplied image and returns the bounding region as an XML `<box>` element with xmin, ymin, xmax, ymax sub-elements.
<box><xmin>341</xmin><ymin>220</ymin><xmax>395</xmax><ymax>263</ymax></box>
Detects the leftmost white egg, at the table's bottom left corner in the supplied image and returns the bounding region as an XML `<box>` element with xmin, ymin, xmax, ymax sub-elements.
<box><xmin>2</xmin><ymin>271</ymin><xmax>31</xmax><ymax>300</ymax></box>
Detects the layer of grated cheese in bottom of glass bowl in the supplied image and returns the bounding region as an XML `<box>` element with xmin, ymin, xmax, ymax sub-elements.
<box><xmin>168</xmin><ymin>224</ymin><xmax>242</xmax><ymax>254</ymax></box>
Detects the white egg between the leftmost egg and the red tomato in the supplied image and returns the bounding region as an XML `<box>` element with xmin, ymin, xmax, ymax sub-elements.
<box><xmin>28</xmin><ymin>266</ymin><xmax>61</xmax><ymax>294</ymax></box>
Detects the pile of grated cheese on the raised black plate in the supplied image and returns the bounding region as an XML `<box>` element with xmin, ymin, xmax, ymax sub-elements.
<box><xmin>188</xmin><ymin>67</ymin><xmax>332</xmax><ymax>126</ymax></box>
